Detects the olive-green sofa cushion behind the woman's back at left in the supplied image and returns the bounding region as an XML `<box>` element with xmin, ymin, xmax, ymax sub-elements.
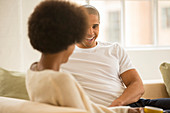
<box><xmin>0</xmin><ymin>68</ymin><xmax>29</xmax><ymax>100</ymax></box>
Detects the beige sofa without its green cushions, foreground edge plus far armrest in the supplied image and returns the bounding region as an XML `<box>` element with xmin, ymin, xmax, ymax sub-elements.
<box><xmin>0</xmin><ymin>82</ymin><xmax>169</xmax><ymax>113</ymax></box>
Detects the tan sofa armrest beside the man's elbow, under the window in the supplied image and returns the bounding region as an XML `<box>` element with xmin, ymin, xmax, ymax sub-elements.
<box><xmin>142</xmin><ymin>80</ymin><xmax>170</xmax><ymax>99</ymax></box>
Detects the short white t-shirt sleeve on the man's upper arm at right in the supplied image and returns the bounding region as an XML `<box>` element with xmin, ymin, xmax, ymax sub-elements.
<box><xmin>117</xmin><ymin>44</ymin><xmax>135</xmax><ymax>75</ymax></box>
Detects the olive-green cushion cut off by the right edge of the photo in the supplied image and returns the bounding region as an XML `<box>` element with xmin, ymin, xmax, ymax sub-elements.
<box><xmin>160</xmin><ymin>62</ymin><xmax>170</xmax><ymax>96</ymax></box>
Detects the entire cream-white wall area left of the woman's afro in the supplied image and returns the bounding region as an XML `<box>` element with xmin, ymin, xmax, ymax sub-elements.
<box><xmin>0</xmin><ymin>0</ymin><xmax>40</xmax><ymax>71</ymax></box>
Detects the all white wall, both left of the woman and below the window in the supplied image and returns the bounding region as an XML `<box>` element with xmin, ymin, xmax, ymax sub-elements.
<box><xmin>0</xmin><ymin>0</ymin><xmax>170</xmax><ymax>80</ymax></box>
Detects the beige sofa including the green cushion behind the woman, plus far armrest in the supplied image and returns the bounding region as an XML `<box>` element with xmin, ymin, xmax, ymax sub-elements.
<box><xmin>0</xmin><ymin>68</ymin><xmax>169</xmax><ymax>113</ymax></box>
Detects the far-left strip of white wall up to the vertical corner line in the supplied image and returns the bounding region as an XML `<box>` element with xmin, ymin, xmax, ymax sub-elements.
<box><xmin>0</xmin><ymin>0</ymin><xmax>22</xmax><ymax>69</ymax></box>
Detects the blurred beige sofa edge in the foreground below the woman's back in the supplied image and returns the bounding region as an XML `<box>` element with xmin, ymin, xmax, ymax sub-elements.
<box><xmin>0</xmin><ymin>97</ymin><xmax>88</xmax><ymax>113</ymax></box>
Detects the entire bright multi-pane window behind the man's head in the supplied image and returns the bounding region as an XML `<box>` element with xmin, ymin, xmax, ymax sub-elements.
<box><xmin>74</xmin><ymin>0</ymin><xmax>170</xmax><ymax>47</ymax></box>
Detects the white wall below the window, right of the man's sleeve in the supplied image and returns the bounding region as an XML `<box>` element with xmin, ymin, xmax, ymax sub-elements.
<box><xmin>127</xmin><ymin>49</ymin><xmax>170</xmax><ymax>80</ymax></box>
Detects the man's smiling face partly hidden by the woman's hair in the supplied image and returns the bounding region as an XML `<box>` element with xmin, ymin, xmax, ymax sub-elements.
<box><xmin>77</xmin><ymin>14</ymin><xmax>99</xmax><ymax>48</ymax></box>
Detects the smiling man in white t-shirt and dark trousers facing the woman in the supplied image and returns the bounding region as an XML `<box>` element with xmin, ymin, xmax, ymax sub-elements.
<box><xmin>61</xmin><ymin>5</ymin><xmax>170</xmax><ymax>109</ymax></box>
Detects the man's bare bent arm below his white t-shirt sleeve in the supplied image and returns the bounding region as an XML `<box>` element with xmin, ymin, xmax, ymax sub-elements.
<box><xmin>110</xmin><ymin>69</ymin><xmax>144</xmax><ymax>107</ymax></box>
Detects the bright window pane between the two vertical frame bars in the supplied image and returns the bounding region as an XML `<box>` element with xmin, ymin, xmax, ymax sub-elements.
<box><xmin>125</xmin><ymin>0</ymin><xmax>154</xmax><ymax>47</ymax></box>
